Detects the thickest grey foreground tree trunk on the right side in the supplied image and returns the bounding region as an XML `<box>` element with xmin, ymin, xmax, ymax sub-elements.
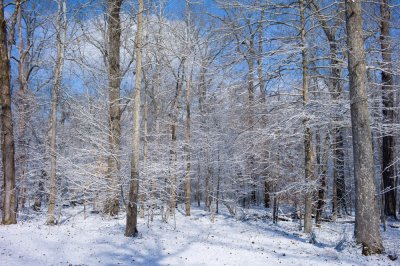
<box><xmin>346</xmin><ymin>0</ymin><xmax>383</xmax><ymax>255</ymax></box>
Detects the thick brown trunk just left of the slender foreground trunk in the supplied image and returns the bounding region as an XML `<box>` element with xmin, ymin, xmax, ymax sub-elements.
<box><xmin>103</xmin><ymin>0</ymin><xmax>123</xmax><ymax>216</ymax></box>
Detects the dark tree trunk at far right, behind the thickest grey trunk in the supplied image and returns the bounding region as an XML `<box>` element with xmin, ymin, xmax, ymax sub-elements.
<box><xmin>380</xmin><ymin>0</ymin><xmax>396</xmax><ymax>217</ymax></box>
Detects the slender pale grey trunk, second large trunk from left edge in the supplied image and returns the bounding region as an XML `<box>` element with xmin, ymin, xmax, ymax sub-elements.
<box><xmin>47</xmin><ymin>0</ymin><xmax>67</xmax><ymax>225</ymax></box>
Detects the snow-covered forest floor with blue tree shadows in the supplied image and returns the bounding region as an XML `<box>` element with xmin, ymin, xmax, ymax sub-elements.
<box><xmin>0</xmin><ymin>207</ymin><xmax>400</xmax><ymax>266</ymax></box>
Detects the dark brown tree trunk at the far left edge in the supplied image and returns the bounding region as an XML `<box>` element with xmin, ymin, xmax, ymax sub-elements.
<box><xmin>0</xmin><ymin>0</ymin><xmax>17</xmax><ymax>224</ymax></box>
